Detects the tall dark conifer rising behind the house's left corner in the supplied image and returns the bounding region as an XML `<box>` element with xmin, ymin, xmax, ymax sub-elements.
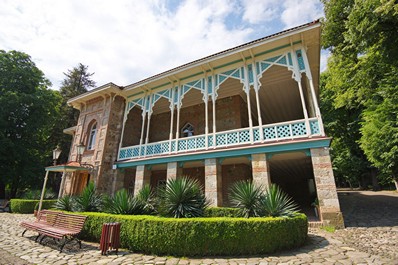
<box><xmin>54</xmin><ymin>63</ymin><xmax>95</xmax><ymax>162</ymax></box>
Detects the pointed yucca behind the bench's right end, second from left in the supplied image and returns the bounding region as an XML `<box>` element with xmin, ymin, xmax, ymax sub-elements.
<box><xmin>73</xmin><ymin>182</ymin><xmax>103</xmax><ymax>212</ymax></box>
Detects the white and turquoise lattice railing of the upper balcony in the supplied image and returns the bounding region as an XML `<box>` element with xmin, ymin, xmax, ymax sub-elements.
<box><xmin>118</xmin><ymin>118</ymin><xmax>321</xmax><ymax>161</ymax></box>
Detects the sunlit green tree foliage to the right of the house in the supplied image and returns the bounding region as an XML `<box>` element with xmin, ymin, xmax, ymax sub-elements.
<box><xmin>321</xmin><ymin>0</ymin><xmax>398</xmax><ymax>190</ymax></box>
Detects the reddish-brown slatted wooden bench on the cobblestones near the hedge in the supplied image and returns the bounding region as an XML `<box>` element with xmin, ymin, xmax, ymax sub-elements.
<box><xmin>20</xmin><ymin>210</ymin><xmax>87</xmax><ymax>252</ymax></box>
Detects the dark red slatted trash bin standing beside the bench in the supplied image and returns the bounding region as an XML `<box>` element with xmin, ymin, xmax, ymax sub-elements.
<box><xmin>100</xmin><ymin>223</ymin><xmax>120</xmax><ymax>255</ymax></box>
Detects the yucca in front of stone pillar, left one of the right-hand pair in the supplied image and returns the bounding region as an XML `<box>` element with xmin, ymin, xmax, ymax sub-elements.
<box><xmin>229</xmin><ymin>180</ymin><xmax>262</xmax><ymax>218</ymax></box>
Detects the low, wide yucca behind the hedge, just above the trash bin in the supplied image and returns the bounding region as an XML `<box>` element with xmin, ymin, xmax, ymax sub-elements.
<box><xmin>103</xmin><ymin>189</ymin><xmax>144</xmax><ymax>214</ymax></box>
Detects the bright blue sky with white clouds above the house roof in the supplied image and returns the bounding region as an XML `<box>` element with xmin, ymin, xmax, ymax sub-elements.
<box><xmin>0</xmin><ymin>0</ymin><xmax>327</xmax><ymax>89</ymax></box>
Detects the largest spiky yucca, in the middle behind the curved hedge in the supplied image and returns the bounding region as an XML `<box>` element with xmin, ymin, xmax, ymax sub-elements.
<box><xmin>158</xmin><ymin>177</ymin><xmax>208</xmax><ymax>218</ymax></box>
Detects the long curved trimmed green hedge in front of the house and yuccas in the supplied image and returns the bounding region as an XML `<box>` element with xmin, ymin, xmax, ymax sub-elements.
<box><xmin>78</xmin><ymin>213</ymin><xmax>308</xmax><ymax>256</ymax></box>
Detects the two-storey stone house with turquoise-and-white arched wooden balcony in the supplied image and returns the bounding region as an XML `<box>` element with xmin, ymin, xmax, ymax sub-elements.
<box><xmin>61</xmin><ymin>21</ymin><xmax>343</xmax><ymax>227</ymax></box>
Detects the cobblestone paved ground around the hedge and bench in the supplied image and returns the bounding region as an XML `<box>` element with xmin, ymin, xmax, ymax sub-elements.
<box><xmin>0</xmin><ymin>192</ymin><xmax>398</xmax><ymax>265</ymax></box>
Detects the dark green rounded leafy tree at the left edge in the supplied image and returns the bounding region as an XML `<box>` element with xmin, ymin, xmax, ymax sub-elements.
<box><xmin>0</xmin><ymin>50</ymin><xmax>61</xmax><ymax>197</ymax></box>
